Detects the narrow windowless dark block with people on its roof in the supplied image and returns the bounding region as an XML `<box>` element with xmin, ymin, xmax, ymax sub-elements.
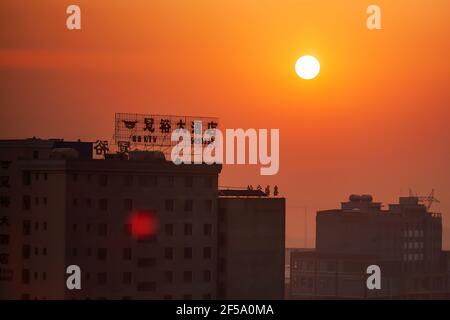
<box><xmin>218</xmin><ymin>190</ymin><xmax>285</xmax><ymax>300</ymax></box>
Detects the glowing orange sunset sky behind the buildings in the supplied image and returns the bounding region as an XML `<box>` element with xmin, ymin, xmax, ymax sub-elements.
<box><xmin>0</xmin><ymin>0</ymin><xmax>450</xmax><ymax>248</ymax></box>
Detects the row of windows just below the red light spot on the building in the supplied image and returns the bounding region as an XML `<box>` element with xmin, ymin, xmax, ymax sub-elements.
<box><xmin>68</xmin><ymin>246</ymin><xmax>212</xmax><ymax>260</ymax></box>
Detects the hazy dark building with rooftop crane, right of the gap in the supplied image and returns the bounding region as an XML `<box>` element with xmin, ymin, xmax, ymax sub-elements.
<box><xmin>290</xmin><ymin>195</ymin><xmax>450</xmax><ymax>299</ymax></box>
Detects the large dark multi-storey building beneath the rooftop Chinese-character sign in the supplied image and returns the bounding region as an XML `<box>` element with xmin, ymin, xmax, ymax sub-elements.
<box><xmin>0</xmin><ymin>140</ymin><xmax>221</xmax><ymax>299</ymax></box>
